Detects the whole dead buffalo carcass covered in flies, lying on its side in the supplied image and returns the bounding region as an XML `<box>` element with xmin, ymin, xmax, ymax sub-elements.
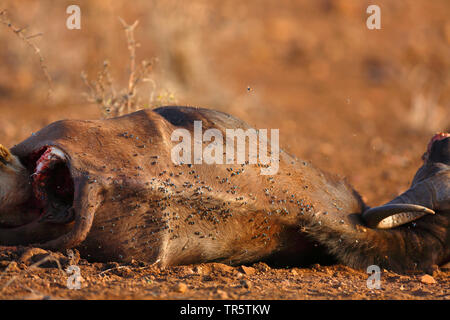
<box><xmin>0</xmin><ymin>107</ymin><xmax>450</xmax><ymax>272</ymax></box>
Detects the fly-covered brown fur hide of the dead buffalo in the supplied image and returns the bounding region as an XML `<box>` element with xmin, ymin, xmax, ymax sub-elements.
<box><xmin>0</xmin><ymin>107</ymin><xmax>449</xmax><ymax>271</ymax></box>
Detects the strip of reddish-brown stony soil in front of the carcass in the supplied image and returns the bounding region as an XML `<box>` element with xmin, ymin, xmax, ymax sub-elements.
<box><xmin>0</xmin><ymin>248</ymin><xmax>450</xmax><ymax>300</ymax></box>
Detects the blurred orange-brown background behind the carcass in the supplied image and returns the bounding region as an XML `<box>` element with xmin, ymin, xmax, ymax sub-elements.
<box><xmin>0</xmin><ymin>0</ymin><xmax>450</xmax><ymax>205</ymax></box>
